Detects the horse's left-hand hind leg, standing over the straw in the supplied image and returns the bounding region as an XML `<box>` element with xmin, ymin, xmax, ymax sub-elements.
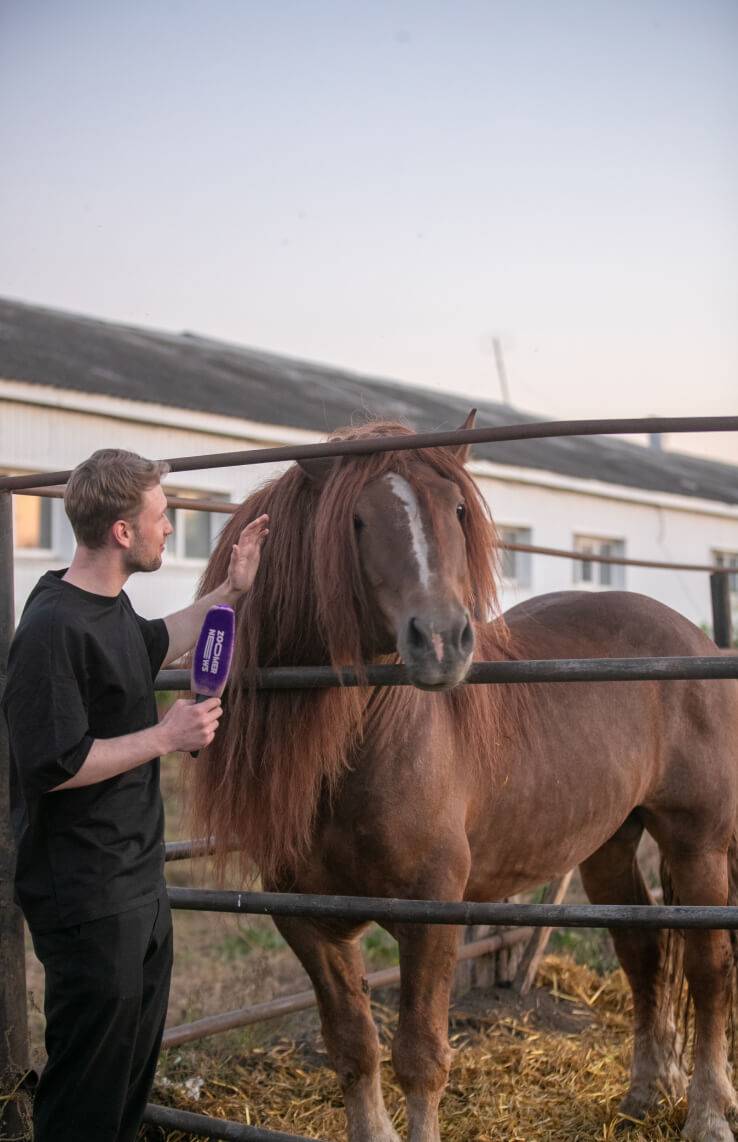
<box><xmin>579</xmin><ymin>815</ymin><xmax>687</xmax><ymax>1118</ymax></box>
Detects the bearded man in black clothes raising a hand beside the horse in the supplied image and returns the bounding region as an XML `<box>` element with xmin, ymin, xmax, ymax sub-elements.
<box><xmin>3</xmin><ymin>449</ymin><xmax>267</xmax><ymax>1142</ymax></box>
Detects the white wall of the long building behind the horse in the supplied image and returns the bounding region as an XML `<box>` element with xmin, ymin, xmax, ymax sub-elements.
<box><xmin>0</xmin><ymin>383</ymin><xmax>738</xmax><ymax>626</ymax></box>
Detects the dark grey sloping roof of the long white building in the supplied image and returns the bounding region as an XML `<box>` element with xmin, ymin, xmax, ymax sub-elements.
<box><xmin>0</xmin><ymin>299</ymin><xmax>738</xmax><ymax>504</ymax></box>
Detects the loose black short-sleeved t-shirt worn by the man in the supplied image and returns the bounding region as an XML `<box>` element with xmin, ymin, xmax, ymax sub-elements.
<box><xmin>2</xmin><ymin>571</ymin><xmax>169</xmax><ymax>932</ymax></box>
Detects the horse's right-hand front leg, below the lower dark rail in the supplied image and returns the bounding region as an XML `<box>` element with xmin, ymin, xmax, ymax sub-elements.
<box><xmin>392</xmin><ymin>924</ymin><xmax>458</xmax><ymax>1142</ymax></box>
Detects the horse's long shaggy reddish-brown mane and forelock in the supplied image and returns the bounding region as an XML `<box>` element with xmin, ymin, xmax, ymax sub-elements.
<box><xmin>191</xmin><ymin>421</ymin><xmax>516</xmax><ymax>883</ymax></box>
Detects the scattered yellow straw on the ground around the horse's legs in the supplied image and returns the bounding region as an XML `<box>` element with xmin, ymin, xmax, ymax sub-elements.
<box><xmin>131</xmin><ymin>956</ymin><xmax>685</xmax><ymax>1142</ymax></box>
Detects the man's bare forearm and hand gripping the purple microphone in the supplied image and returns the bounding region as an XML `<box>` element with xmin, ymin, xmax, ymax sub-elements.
<box><xmin>51</xmin><ymin>698</ymin><xmax>223</xmax><ymax>793</ymax></box>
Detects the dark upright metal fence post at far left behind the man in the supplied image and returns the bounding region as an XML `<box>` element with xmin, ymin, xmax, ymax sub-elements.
<box><xmin>0</xmin><ymin>492</ymin><xmax>29</xmax><ymax>1137</ymax></box>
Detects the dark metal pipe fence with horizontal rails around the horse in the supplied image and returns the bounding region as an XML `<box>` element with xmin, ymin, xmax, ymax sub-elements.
<box><xmin>0</xmin><ymin>417</ymin><xmax>738</xmax><ymax>1142</ymax></box>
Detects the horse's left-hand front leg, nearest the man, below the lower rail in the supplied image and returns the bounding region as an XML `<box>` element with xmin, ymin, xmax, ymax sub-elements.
<box><xmin>271</xmin><ymin>917</ymin><xmax>400</xmax><ymax>1142</ymax></box>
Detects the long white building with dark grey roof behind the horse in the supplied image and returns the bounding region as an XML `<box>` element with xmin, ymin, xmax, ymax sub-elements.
<box><xmin>0</xmin><ymin>301</ymin><xmax>738</xmax><ymax>626</ymax></box>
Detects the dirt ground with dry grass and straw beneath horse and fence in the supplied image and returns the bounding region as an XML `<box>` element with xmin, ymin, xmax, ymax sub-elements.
<box><xmin>12</xmin><ymin>761</ymin><xmax>679</xmax><ymax>1142</ymax></box>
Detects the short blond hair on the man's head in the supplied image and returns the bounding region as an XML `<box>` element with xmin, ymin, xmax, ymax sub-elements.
<box><xmin>64</xmin><ymin>448</ymin><xmax>169</xmax><ymax>548</ymax></box>
